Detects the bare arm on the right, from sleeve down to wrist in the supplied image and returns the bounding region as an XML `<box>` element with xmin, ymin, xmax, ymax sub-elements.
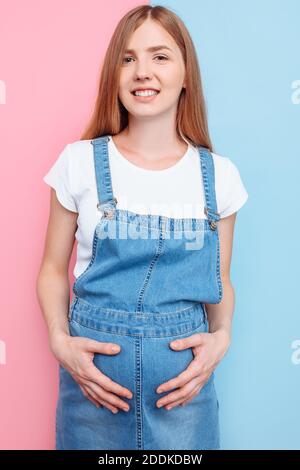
<box><xmin>205</xmin><ymin>212</ymin><xmax>237</xmax><ymax>345</ymax></box>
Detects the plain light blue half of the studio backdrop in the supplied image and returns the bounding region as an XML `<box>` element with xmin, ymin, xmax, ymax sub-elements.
<box><xmin>150</xmin><ymin>0</ymin><xmax>300</xmax><ymax>449</ymax></box>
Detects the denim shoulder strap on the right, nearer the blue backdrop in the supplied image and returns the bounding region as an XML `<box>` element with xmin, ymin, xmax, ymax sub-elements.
<box><xmin>198</xmin><ymin>145</ymin><xmax>220</xmax><ymax>230</ymax></box>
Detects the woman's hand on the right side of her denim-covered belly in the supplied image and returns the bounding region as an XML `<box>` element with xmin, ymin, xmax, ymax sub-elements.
<box><xmin>156</xmin><ymin>329</ymin><xmax>230</xmax><ymax>410</ymax></box>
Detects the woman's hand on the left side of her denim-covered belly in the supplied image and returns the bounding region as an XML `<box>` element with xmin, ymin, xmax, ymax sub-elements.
<box><xmin>50</xmin><ymin>333</ymin><xmax>132</xmax><ymax>413</ymax></box>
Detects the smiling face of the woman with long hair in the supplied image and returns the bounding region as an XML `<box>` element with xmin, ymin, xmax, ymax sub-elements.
<box><xmin>119</xmin><ymin>19</ymin><xmax>185</xmax><ymax>117</ymax></box>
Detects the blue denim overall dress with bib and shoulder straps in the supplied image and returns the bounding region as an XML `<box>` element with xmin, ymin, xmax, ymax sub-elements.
<box><xmin>56</xmin><ymin>135</ymin><xmax>222</xmax><ymax>450</ymax></box>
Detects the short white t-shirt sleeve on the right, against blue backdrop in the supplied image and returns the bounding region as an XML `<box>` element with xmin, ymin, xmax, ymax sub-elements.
<box><xmin>220</xmin><ymin>158</ymin><xmax>248</xmax><ymax>218</ymax></box>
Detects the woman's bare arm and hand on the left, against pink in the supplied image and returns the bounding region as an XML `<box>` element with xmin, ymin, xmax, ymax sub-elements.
<box><xmin>36</xmin><ymin>188</ymin><xmax>132</xmax><ymax>413</ymax></box>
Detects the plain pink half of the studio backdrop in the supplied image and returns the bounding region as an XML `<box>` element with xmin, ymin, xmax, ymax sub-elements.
<box><xmin>0</xmin><ymin>0</ymin><xmax>147</xmax><ymax>449</ymax></box>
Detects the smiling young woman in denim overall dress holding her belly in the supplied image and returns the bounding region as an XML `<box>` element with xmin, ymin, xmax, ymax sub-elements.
<box><xmin>37</xmin><ymin>5</ymin><xmax>248</xmax><ymax>450</ymax></box>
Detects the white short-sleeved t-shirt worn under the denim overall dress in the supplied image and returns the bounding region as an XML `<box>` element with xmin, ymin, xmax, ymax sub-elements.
<box><xmin>43</xmin><ymin>139</ymin><xmax>248</xmax><ymax>278</ymax></box>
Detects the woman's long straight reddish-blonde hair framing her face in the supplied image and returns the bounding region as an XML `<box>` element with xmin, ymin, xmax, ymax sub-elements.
<box><xmin>80</xmin><ymin>5</ymin><xmax>213</xmax><ymax>152</ymax></box>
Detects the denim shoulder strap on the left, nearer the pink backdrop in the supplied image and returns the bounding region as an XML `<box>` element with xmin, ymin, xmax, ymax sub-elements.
<box><xmin>91</xmin><ymin>135</ymin><xmax>117</xmax><ymax>215</ymax></box>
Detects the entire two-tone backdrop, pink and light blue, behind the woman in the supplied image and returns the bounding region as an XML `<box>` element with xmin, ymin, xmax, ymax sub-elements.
<box><xmin>0</xmin><ymin>0</ymin><xmax>300</xmax><ymax>449</ymax></box>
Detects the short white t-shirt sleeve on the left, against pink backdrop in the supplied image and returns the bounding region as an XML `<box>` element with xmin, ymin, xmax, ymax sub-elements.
<box><xmin>43</xmin><ymin>144</ymin><xmax>78</xmax><ymax>212</ymax></box>
